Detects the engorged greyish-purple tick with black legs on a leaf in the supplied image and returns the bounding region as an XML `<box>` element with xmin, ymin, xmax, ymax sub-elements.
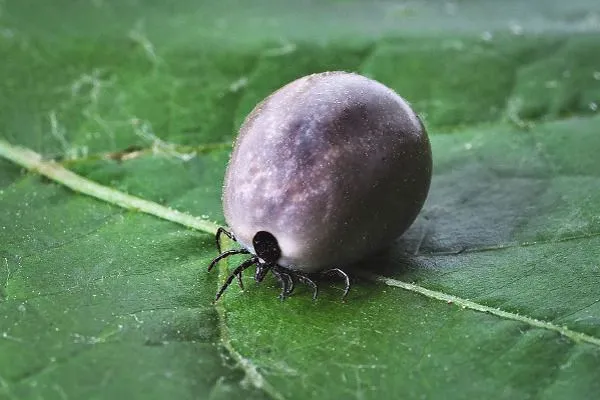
<box><xmin>209</xmin><ymin>72</ymin><xmax>432</xmax><ymax>299</ymax></box>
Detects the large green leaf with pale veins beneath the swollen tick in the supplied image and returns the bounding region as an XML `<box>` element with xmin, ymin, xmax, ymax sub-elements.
<box><xmin>0</xmin><ymin>0</ymin><xmax>600</xmax><ymax>399</ymax></box>
